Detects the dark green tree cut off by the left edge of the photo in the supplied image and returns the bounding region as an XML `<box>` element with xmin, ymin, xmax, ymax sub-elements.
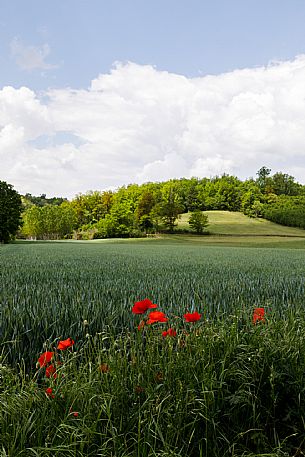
<box><xmin>0</xmin><ymin>181</ymin><xmax>22</xmax><ymax>243</ymax></box>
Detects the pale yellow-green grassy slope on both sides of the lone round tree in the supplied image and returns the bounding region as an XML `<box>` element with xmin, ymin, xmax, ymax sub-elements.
<box><xmin>178</xmin><ymin>211</ymin><xmax>305</xmax><ymax>238</ymax></box>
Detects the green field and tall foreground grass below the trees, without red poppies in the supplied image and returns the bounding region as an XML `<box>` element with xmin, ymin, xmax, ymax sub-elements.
<box><xmin>0</xmin><ymin>236</ymin><xmax>305</xmax><ymax>457</ymax></box>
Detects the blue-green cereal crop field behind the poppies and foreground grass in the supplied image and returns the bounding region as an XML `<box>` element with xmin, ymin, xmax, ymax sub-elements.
<box><xmin>0</xmin><ymin>237</ymin><xmax>305</xmax><ymax>361</ymax></box>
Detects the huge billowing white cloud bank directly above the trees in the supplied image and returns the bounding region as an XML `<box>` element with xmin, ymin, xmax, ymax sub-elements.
<box><xmin>0</xmin><ymin>56</ymin><xmax>305</xmax><ymax>197</ymax></box>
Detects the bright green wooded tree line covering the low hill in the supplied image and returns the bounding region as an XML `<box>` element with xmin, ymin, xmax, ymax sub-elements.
<box><xmin>16</xmin><ymin>167</ymin><xmax>305</xmax><ymax>239</ymax></box>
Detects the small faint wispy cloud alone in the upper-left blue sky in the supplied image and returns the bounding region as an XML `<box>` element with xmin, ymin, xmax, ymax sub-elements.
<box><xmin>10</xmin><ymin>38</ymin><xmax>57</xmax><ymax>71</ymax></box>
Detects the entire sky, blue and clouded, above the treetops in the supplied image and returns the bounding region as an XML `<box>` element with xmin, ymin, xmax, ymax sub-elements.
<box><xmin>0</xmin><ymin>0</ymin><xmax>305</xmax><ymax>198</ymax></box>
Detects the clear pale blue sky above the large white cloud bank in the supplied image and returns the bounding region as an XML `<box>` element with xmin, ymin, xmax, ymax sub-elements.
<box><xmin>0</xmin><ymin>0</ymin><xmax>305</xmax><ymax>89</ymax></box>
